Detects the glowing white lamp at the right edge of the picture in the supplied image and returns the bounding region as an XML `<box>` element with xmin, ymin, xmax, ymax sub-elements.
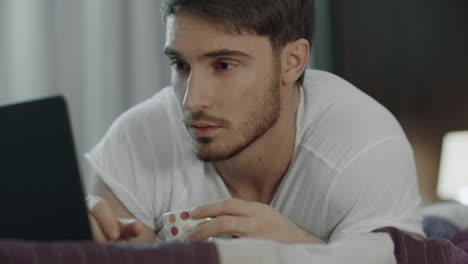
<box><xmin>437</xmin><ymin>131</ymin><xmax>468</xmax><ymax>205</ymax></box>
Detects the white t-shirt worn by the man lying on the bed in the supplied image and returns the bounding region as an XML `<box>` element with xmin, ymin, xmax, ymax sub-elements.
<box><xmin>86</xmin><ymin>70</ymin><xmax>423</xmax><ymax>262</ymax></box>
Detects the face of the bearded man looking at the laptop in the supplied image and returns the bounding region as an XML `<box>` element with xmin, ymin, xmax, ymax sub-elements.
<box><xmin>165</xmin><ymin>12</ymin><xmax>280</xmax><ymax>161</ymax></box>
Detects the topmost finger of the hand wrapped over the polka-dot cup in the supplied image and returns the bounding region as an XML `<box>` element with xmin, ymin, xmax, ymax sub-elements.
<box><xmin>190</xmin><ymin>199</ymin><xmax>265</xmax><ymax>219</ymax></box>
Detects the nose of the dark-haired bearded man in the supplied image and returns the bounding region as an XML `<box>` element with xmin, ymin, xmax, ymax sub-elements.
<box><xmin>183</xmin><ymin>69</ymin><xmax>213</xmax><ymax>112</ymax></box>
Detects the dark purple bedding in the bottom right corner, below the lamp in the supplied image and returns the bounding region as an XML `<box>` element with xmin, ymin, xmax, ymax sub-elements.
<box><xmin>374</xmin><ymin>227</ymin><xmax>468</xmax><ymax>264</ymax></box>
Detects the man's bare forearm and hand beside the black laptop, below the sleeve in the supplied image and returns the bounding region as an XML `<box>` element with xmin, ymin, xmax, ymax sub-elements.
<box><xmin>87</xmin><ymin>175</ymin><xmax>155</xmax><ymax>243</ymax></box>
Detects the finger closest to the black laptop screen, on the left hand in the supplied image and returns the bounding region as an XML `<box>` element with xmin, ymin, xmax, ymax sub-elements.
<box><xmin>87</xmin><ymin>196</ymin><xmax>120</xmax><ymax>241</ymax></box>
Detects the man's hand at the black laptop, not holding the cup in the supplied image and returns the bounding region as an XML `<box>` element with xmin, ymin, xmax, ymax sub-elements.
<box><xmin>86</xmin><ymin>195</ymin><xmax>143</xmax><ymax>242</ymax></box>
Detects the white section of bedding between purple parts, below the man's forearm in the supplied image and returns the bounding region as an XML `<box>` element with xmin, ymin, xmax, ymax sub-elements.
<box><xmin>216</xmin><ymin>233</ymin><xmax>396</xmax><ymax>264</ymax></box>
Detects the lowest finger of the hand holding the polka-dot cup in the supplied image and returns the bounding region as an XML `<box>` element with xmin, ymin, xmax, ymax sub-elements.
<box><xmin>187</xmin><ymin>216</ymin><xmax>253</xmax><ymax>240</ymax></box>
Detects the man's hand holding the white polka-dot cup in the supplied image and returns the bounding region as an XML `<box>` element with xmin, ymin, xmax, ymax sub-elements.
<box><xmin>187</xmin><ymin>199</ymin><xmax>324</xmax><ymax>244</ymax></box>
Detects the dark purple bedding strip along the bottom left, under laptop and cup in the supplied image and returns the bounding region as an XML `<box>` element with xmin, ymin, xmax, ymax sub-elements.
<box><xmin>0</xmin><ymin>241</ymin><xmax>218</xmax><ymax>264</ymax></box>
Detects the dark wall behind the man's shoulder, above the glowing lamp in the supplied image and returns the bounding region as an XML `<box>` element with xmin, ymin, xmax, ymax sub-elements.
<box><xmin>328</xmin><ymin>0</ymin><xmax>468</xmax><ymax>204</ymax></box>
